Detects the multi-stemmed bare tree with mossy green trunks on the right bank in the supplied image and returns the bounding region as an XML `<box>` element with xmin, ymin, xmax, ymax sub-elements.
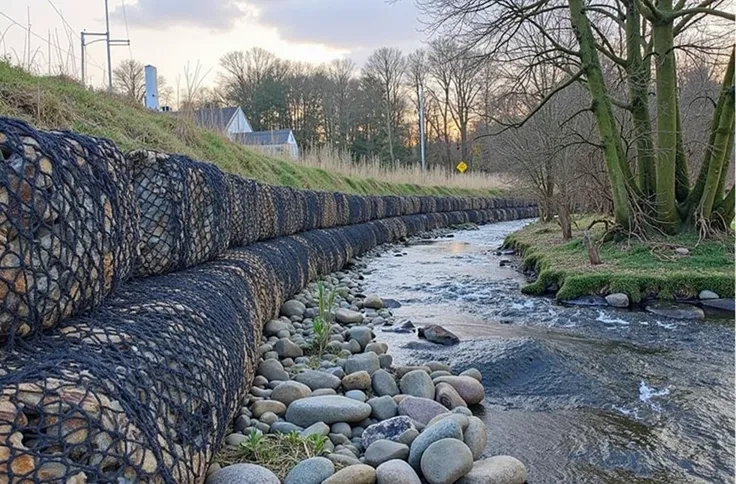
<box><xmin>416</xmin><ymin>0</ymin><xmax>735</xmax><ymax>232</ymax></box>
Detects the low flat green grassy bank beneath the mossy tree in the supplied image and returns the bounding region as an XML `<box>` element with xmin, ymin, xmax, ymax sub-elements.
<box><xmin>506</xmin><ymin>217</ymin><xmax>734</xmax><ymax>302</ymax></box>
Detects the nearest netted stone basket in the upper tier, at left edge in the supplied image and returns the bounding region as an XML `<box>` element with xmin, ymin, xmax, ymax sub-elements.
<box><xmin>0</xmin><ymin>118</ymin><xmax>138</xmax><ymax>340</ymax></box>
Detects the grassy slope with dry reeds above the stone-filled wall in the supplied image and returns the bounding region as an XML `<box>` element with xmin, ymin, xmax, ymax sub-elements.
<box><xmin>0</xmin><ymin>62</ymin><xmax>502</xmax><ymax>195</ymax></box>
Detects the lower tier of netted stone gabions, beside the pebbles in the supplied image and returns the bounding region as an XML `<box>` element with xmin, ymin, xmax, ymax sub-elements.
<box><xmin>0</xmin><ymin>207</ymin><xmax>535</xmax><ymax>483</ymax></box>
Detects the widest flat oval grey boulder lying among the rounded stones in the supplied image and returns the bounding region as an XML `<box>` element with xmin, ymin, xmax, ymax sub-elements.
<box><xmin>285</xmin><ymin>395</ymin><xmax>371</xmax><ymax>427</ymax></box>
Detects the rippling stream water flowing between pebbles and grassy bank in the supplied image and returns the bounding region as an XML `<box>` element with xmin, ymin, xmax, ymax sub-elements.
<box><xmin>364</xmin><ymin>221</ymin><xmax>735</xmax><ymax>484</ymax></box>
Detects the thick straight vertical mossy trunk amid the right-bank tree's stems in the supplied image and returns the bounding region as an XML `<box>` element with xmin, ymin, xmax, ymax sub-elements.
<box><xmin>652</xmin><ymin>5</ymin><xmax>679</xmax><ymax>233</ymax></box>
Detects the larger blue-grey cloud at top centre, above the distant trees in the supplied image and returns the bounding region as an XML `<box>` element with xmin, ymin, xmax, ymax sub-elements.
<box><xmin>249</xmin><ymin>0</ymin><xmax>422</xmax><ymax>50</ymax></box>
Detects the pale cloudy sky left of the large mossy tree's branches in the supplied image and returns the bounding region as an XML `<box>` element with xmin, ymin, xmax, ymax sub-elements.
<box><xmin>0</xmin><ymin>0</ymin><xmax>426</xmax><ymax>86</ymax></box>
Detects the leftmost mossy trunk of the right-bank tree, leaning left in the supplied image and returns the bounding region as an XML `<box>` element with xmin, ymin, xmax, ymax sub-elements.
<box><xmin>568</xmin><ymin>0</ymin><xmax>633</xmax><ymax>229</ymax></box>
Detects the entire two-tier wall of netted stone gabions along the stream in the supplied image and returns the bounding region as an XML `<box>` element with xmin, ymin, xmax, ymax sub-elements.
<box><xmin>0</xmin><ymin>119</ymin><xmax>536</xmax><ymax>484</ymax></box>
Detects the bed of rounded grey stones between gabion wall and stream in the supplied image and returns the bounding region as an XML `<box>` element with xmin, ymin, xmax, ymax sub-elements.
<box><xmin>207</xmin><ymin>233</ymin><xmax>527</xmax><ymax>484</ymax></box>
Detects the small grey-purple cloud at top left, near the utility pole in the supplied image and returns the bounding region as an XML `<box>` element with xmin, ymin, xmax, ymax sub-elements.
<box><xmin>112</xmin><ymin>0</ymin><xmax>248</xmax><ymax>30</ymax></box>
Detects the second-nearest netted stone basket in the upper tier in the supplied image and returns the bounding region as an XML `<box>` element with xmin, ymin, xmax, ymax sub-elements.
<box><xmin>125</xmin><ymin>150</ymin><xmax>231</xmax><ymax>276</ymax></box>
